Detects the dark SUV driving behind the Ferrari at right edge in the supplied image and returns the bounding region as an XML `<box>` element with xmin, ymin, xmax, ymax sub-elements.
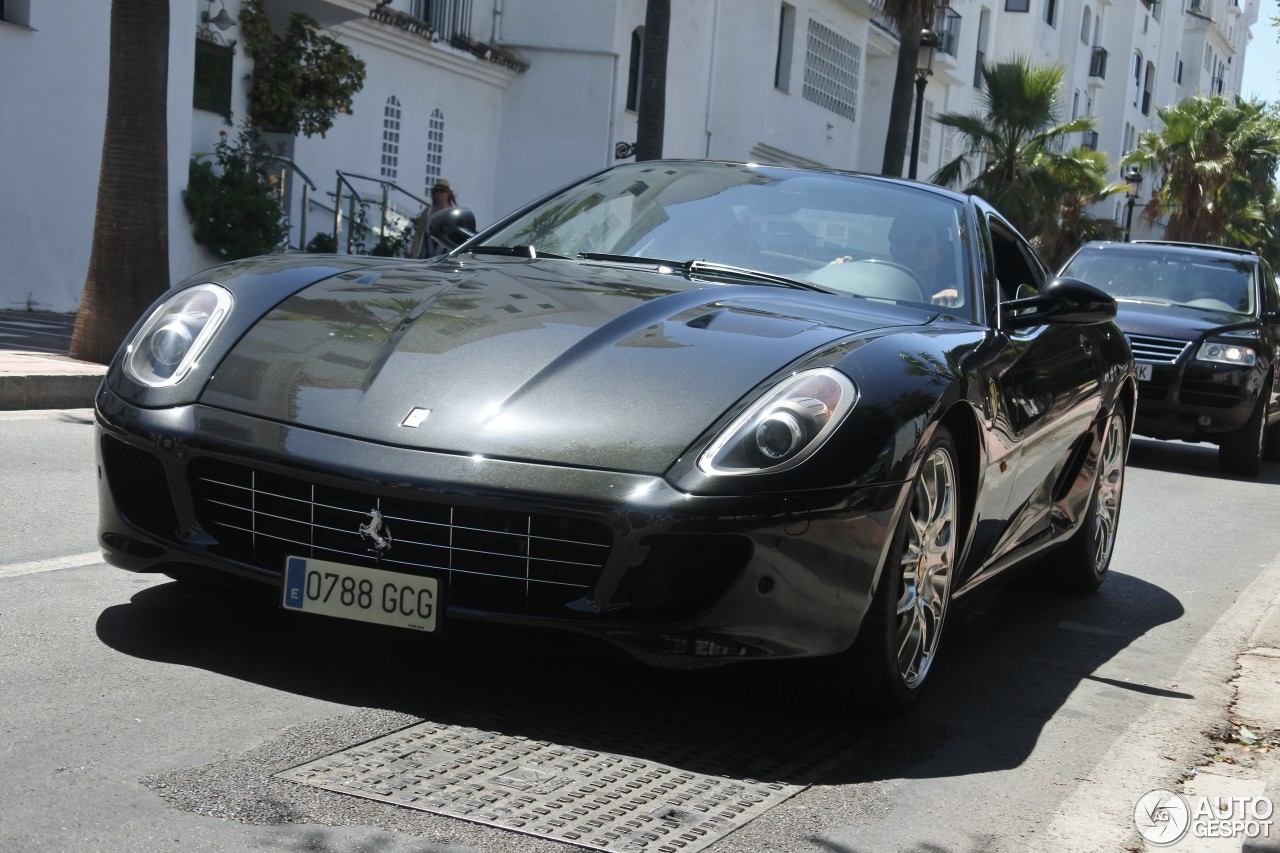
<box><xmin>1061</xmin><ymin>240</ymin><xmax>1280</xmax><ymax>476</ymax></box>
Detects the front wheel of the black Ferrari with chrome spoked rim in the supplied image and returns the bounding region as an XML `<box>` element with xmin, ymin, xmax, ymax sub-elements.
<box><xmin>842</xmin><ymin>425</ymin><xmax>960</xmax><ymax>711</ymax></box>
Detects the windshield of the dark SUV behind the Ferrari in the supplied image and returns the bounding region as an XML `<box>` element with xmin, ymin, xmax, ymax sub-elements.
<box><xmin>1062</xmin><ymin>245</ymin><xmax>1256</xmax><ymax>315</ymax></box>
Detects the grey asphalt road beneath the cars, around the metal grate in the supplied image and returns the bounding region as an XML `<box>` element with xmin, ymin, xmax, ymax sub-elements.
<box><xmin>0</xmin><ymin>411</ymin><xmax>1280</xmax><ymax>853</ymax></box>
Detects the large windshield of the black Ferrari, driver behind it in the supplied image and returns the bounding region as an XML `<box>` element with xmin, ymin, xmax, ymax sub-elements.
<box><xmin>481</xmin><ymin>163</ymin><xmax>973</xmax><ymax>314</ymax></box>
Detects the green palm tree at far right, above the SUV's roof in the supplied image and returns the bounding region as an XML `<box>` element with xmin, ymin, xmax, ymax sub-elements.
<box><xmin>1125</xmin><ymin>97</ymin><xmax>1280</xmax><ymax>248</ymax></box>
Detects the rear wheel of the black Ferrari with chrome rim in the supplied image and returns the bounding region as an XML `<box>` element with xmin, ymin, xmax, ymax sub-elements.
<box><xmin>1048</xmin><ymin>409</ymin><xmax>1129</xmax><ymax>592</ymax></box>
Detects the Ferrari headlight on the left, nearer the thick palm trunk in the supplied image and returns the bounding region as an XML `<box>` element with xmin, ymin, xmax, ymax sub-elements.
<box><xmin>124</xmin><ymin>284</ymin><xmax>234</xmax><ymax>388</ymax></box>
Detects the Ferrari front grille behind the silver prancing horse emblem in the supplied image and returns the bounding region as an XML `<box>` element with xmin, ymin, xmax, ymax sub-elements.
<box><xmin>191</xmin><ymin>459</ymin><xmax>612</xmax><ymax>612</ymax></box>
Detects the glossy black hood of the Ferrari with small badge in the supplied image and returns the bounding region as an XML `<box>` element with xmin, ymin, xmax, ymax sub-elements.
<box><xmin>201</xmin><ymin>259</ymin><xmax>932</xmax><ymax>474</ymax></box>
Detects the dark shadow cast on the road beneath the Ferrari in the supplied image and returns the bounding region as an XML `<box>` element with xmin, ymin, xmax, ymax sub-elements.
<box><xmin>97</xmin><ymin>560</ymin><xmax>1190</xmax><ymax>784</ymax></box>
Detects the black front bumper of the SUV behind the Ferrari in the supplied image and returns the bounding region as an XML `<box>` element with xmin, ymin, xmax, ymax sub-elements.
<box><xmin>1134</xmin><ymin>360</ymin><xmax>1265</xmax><ymax>442</ymax></box>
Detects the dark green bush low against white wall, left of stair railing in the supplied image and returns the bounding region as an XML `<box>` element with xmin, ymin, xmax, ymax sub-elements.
<box><xmin>182</xmin><ymin>133</ymin><xmax>289</xmax><ymax>260</ymax></box>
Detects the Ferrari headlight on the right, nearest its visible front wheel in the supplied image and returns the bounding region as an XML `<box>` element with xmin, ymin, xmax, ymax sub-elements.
<box><xmin>698</xmin><ymin>368</ymin><xmax>858</xmax><ymax>475</ymax></box>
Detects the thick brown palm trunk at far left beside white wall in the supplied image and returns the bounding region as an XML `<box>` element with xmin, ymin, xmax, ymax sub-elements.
<box><xmin>70</xmin><ymin>0</ymin><xmax>169</xmax><ymax>364</ymax></box>
